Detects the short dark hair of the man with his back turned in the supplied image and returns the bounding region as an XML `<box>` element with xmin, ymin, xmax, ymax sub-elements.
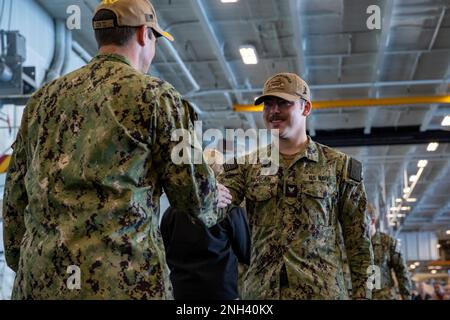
<box><xmin>93</xmin><ymin>9</ymin><xmax>153</xmax><ymax>47</ymax></box>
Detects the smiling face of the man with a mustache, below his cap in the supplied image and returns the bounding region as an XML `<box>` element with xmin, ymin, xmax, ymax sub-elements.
<box><xmin>263</xmin><ymin>97</ymin><xmax>305</xmax><ymax>139</ymax></box>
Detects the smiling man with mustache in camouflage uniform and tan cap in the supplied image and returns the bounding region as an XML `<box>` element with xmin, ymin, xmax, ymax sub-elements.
<box><xmin>220</xmin><ymin>73</ymin><xmax>373</xmax><ymax>299</ymax></box>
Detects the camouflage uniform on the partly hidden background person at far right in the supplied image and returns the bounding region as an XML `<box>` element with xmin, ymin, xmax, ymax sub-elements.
<box><xmin>372</xmin><ymin>232</ymin><xmax>412</xmax><ymax>300</ymax></box>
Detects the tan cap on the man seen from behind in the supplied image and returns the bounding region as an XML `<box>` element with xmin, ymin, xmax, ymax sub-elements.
<box><xmin>92</xmin><ymin>0</ymin><xmax>174</xmax><ymax>41</ymax></box>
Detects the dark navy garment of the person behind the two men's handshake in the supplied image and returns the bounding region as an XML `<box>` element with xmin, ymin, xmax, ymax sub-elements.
<box><xmin>161</xmin><ymin>207</ymin><xmax>251</xmax><ymax>300</ymax></box>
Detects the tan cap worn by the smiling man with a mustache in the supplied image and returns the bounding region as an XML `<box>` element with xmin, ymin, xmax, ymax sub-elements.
<box><xmin>255</xmin><ymin>73</ymin><xmax>311</xmax><ymax>105</ymax></box>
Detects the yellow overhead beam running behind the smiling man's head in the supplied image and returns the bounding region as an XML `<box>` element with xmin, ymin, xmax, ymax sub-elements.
<box><xmin>233</xmin><ymin>95</ymin><xmax>450</xmax><ymax>112</ymax></box>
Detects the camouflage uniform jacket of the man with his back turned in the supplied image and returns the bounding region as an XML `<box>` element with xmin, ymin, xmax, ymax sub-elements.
<box><xmin>3</xmin><ymin>55</ymin><xmax>217</xmax><ymax>299</ymax></box>
